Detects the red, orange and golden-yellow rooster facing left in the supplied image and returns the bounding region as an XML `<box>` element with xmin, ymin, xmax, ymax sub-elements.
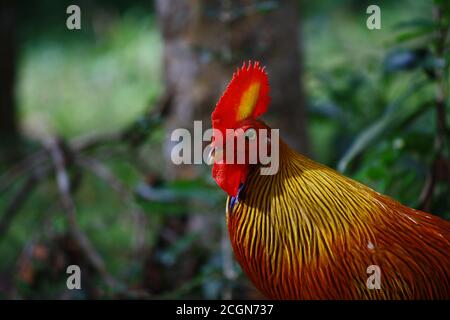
<box><xmin>210</xmin><ymin>62</ymin><xmax>450</xmax><ymax>299</ymax></box>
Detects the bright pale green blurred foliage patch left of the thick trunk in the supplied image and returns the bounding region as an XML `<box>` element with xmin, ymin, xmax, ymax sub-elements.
<box><xmin>18</xmin><ymin>11</ymin><xmax>163</xmax><ymax>137</ymax></box>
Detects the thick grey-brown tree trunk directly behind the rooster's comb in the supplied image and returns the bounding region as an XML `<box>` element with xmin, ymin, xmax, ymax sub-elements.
<box><xmin>156</xmin><ymin>0</ymin><xmax>308</xmax><ymax>177</ymax></box>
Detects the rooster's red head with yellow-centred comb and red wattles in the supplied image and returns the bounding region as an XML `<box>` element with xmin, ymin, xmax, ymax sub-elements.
<box><xmin>211</xmin><ymin>61</ymin><xmax>270</xmax><ymax>196</ymax></box>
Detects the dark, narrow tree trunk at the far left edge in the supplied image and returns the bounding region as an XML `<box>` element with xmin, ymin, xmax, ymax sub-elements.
<box><xmin>0</xmin><ymin>0</ymin><xmax>18</xmax><ymax>154</ymax></box>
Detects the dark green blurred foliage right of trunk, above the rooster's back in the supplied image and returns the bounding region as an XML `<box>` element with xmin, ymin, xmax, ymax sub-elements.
<box><xmin>305</xmin><ymin>1</ymin><xmax>450</xmax><ymax>218</ymax></box>
